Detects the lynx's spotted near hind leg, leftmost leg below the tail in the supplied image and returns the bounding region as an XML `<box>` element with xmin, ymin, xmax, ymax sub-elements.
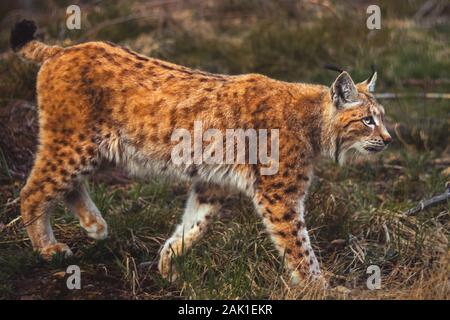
<box><xmin>20</xmin><ymin>128</ymin><xmax>98</xmax><ymax>258</ymax></box>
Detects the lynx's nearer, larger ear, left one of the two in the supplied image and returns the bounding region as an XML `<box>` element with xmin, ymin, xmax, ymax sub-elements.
<box><xmin>331</xmin><ymin>71</ymin><xmax>358</xmax><ymax>108</ymax></box>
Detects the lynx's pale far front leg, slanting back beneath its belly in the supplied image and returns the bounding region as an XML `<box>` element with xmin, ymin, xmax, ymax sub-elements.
<box><xmin>158</xmin><ymin>183</ymin><xmax>223</xmax><ymax>281</ymax></box>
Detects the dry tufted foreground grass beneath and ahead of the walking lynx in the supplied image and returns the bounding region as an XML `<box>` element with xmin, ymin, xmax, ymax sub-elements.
<box><xmin>0</xmin><ymin>144</ymin><xmax>449</xmax><ymax>299</ymax></box>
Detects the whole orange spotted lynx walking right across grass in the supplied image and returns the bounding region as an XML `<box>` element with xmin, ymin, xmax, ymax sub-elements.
<box><xmin>10</xmin><ymin>20</ymin><xmax>391</xmax><ymax>283</ymax></box>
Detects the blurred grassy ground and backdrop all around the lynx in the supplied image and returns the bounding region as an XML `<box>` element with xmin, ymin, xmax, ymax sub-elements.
<box><xmin>0</xmin><ymin>0</ymin><xmax>450</xmax><ymax>299</ymax></box>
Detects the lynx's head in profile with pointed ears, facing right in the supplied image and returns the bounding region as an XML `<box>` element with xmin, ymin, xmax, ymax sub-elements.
<box><xmin>329</xmin><ymin>71</ymin><xmax>392</xmax><ymax>163</ymax></box>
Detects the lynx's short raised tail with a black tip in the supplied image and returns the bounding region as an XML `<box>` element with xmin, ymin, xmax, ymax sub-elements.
<box><xmin>10</xmin><ymin>20</ymin><xmax>63</xmax><ymax>63</ymax></box>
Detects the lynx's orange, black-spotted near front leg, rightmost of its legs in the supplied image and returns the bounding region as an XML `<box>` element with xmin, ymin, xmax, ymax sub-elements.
<box><xmin>254</xmin><ymin>171</ymin><xmax>325</xmax><ymax>284</ymax></box>
